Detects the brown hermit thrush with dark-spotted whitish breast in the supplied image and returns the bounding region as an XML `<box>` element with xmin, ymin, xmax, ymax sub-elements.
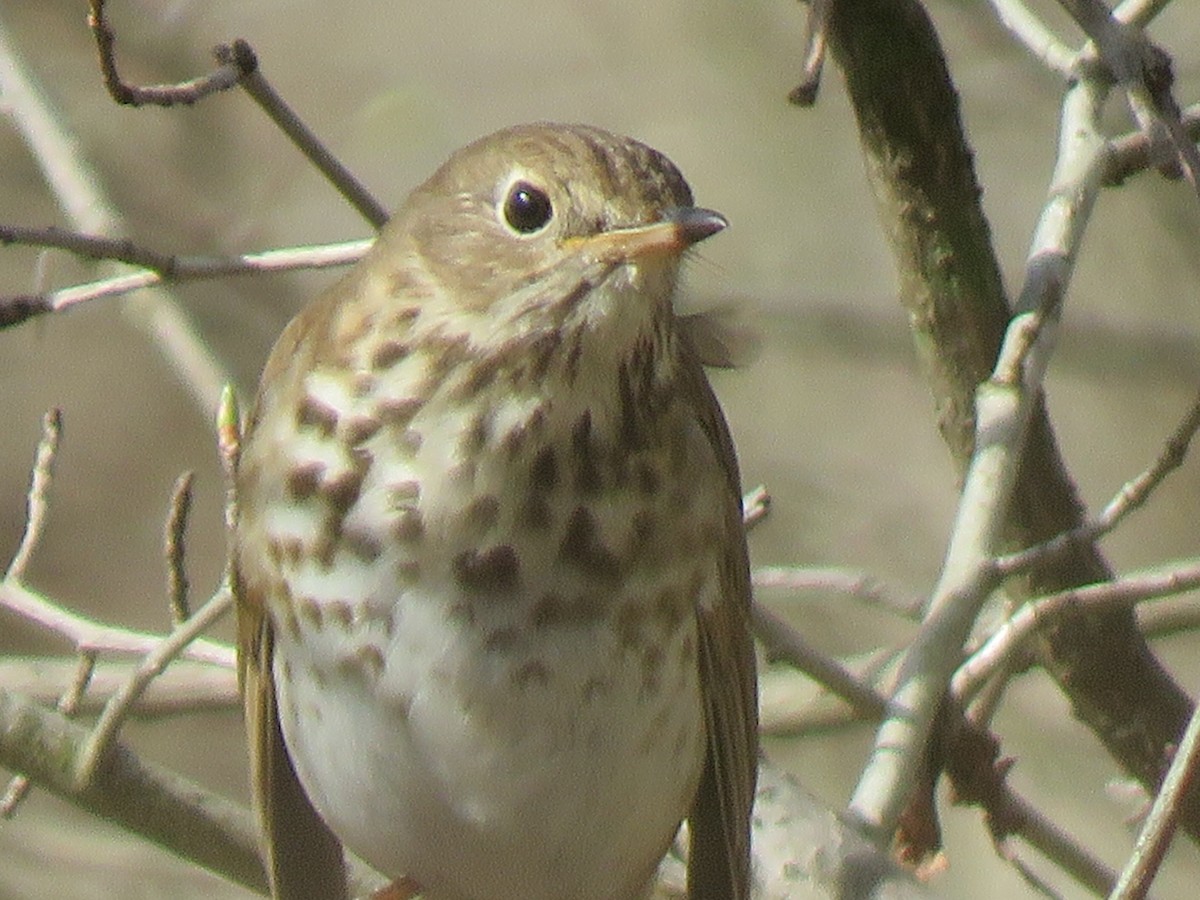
<box><xmin>234</xmin><ymin>125</ymin><xmax>757</xmax><ymax>900</ymax></box>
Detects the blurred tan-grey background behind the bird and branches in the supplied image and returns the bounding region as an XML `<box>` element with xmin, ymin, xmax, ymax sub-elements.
<box><xmin>0</xmin><ymin>0</ymin><xmax>1200</xmax><ymax>900</ymax></box>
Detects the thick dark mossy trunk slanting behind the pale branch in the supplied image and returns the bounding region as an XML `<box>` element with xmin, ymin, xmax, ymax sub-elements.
<box><xmin>830</xmin><ymin>0</ymin><xmax>1200</xmax><ymax>833</ymax></box>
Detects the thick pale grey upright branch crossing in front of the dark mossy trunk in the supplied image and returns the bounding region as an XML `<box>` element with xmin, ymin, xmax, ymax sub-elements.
<box><xmin>850</xmin><ymin>68</ymin><xmax>1105</xmax><ymax>841</ymax></box>
